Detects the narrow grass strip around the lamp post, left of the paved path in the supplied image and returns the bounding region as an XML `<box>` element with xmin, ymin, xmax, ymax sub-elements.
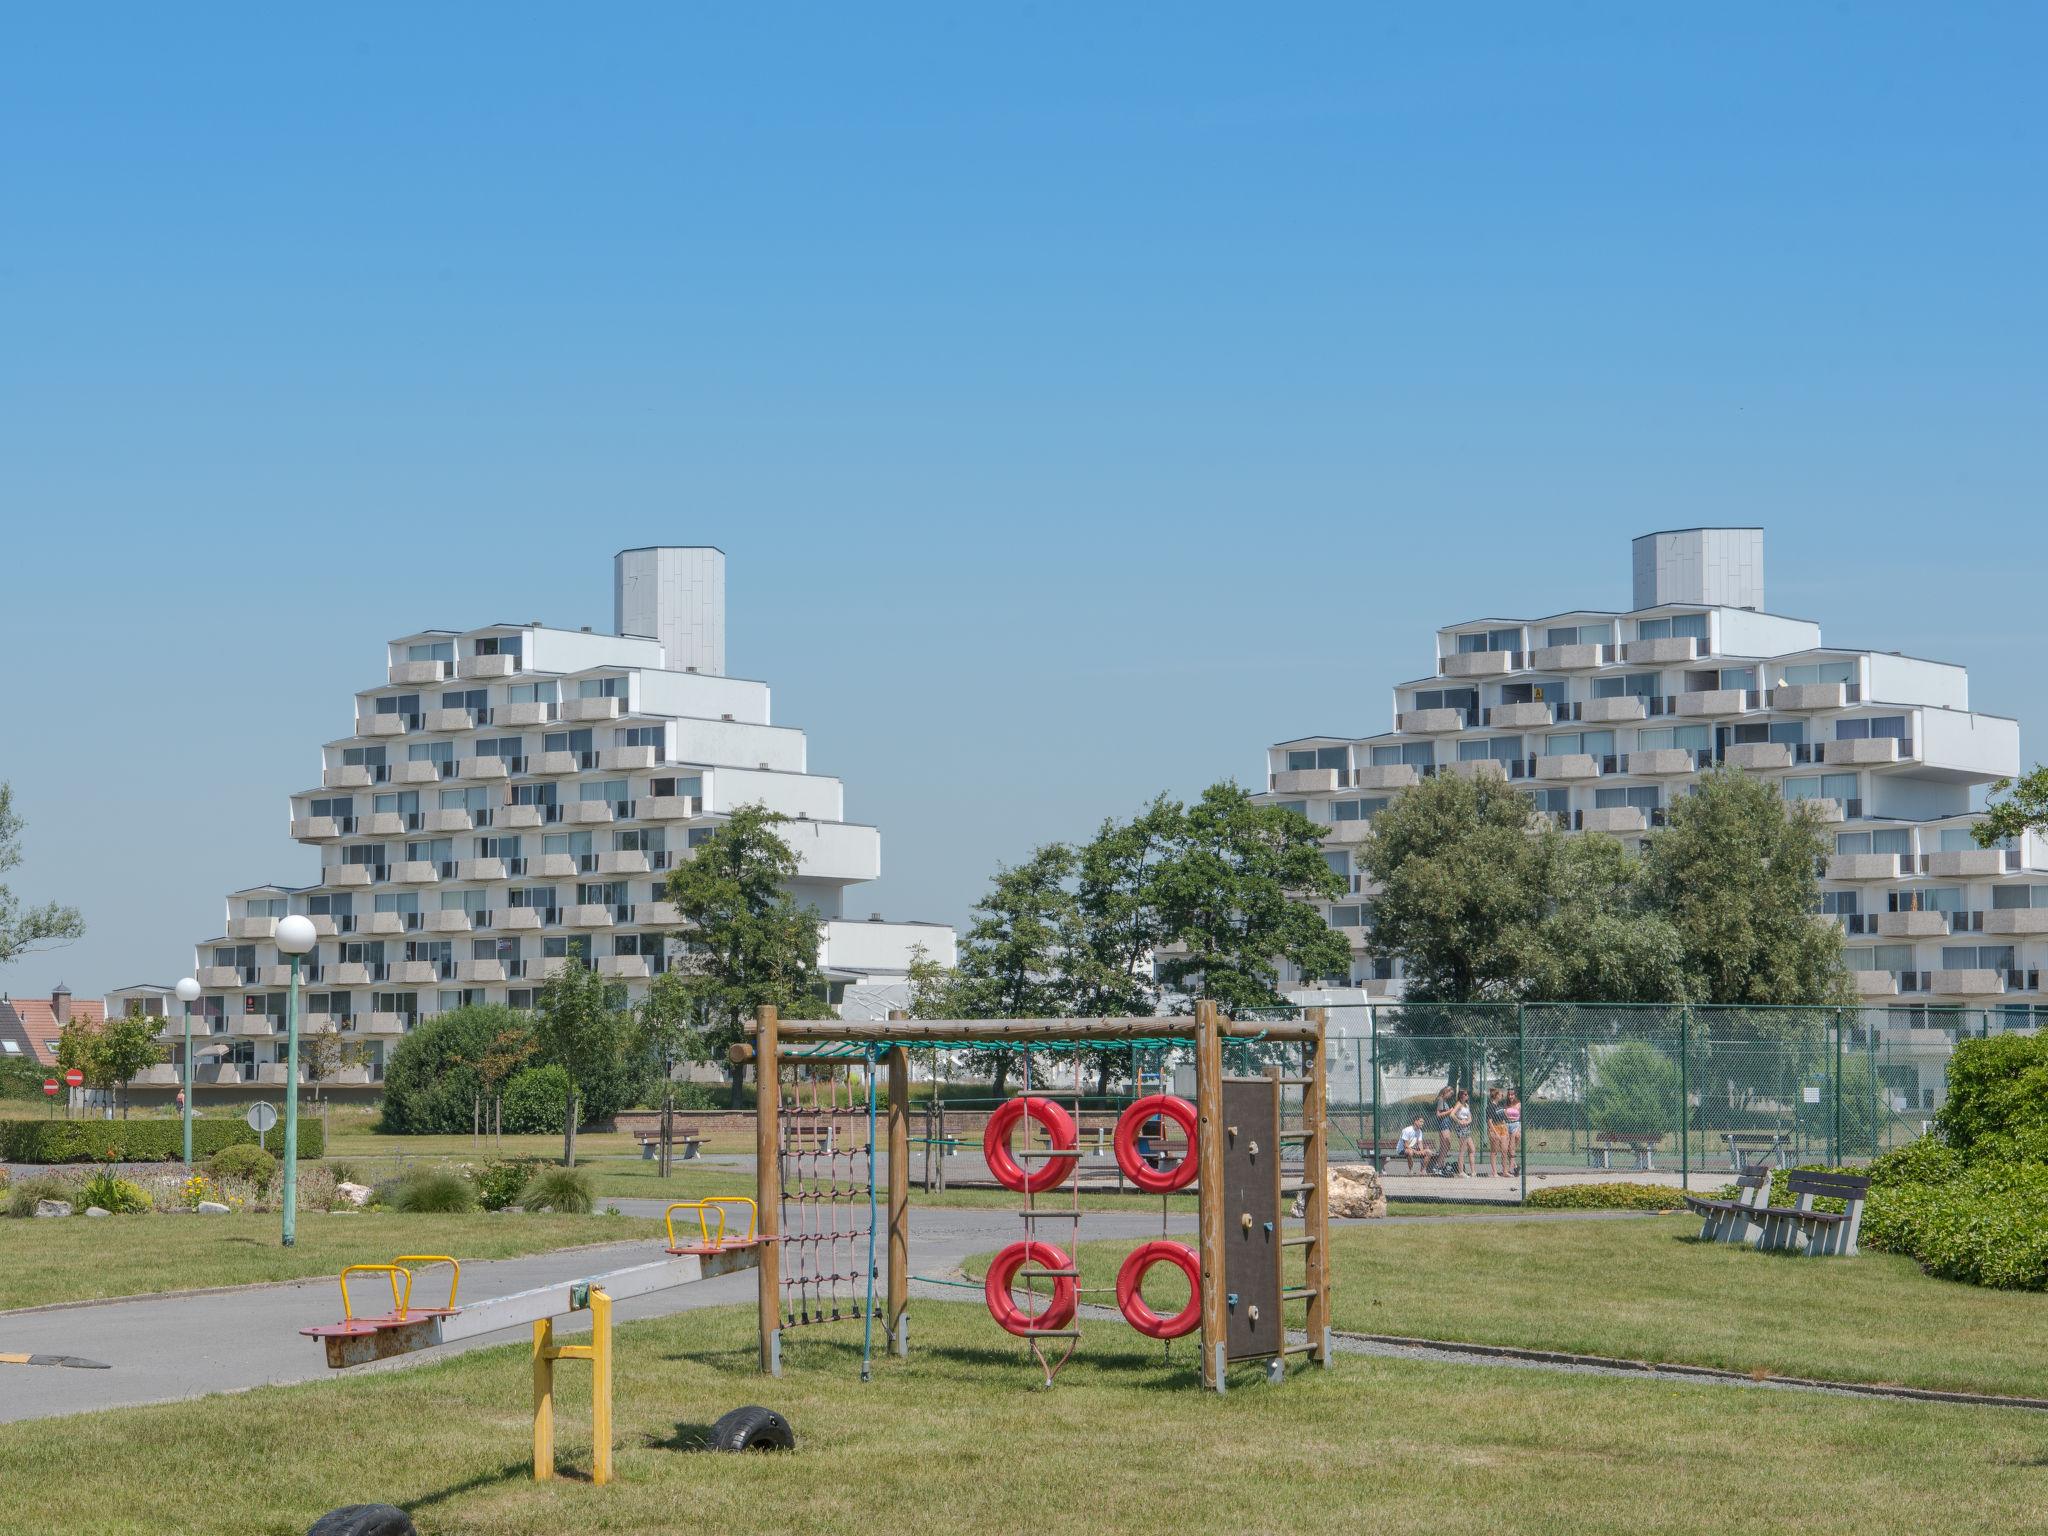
<box><xmin>0</xmin><ymin>1212</ymin><xmax>662</xmax><ymax>1310</ymax></box>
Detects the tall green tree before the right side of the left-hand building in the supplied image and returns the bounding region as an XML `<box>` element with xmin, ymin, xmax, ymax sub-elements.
<box><xmin>668</xmin><ymin>805</ymin><xmax>831</xmax><ymax>1106</ymax></box>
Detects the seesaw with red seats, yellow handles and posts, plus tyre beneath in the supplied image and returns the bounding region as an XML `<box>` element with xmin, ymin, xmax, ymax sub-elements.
<box><xmin>301</xmin><ymin>1196</ymin><xmax>770</xmax><ymax>1483</ymax></box>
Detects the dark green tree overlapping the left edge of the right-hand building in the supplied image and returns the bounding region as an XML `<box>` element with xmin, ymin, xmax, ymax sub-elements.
<box><xmin>1149</xmin><ymin>782</ymin><xmax>1352</xmax><ymax>1014</ymax></box>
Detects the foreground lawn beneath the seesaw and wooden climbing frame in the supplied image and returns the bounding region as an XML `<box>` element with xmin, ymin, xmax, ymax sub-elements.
<box><xmin>0</xmin><ymin>1305</ymin><xmax>2048</xmax><ymax>1536</ymax></box>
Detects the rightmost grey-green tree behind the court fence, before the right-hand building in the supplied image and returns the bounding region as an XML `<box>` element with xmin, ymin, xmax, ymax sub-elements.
<box><xmin>1642</xmin><ymin>768</ymin><xmax>1855</xmax><ymax>1011</ymax></box>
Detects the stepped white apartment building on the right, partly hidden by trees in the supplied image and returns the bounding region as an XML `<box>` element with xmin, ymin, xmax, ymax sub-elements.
<box><xmin>1264</xmin><ymin>528</ymin><xmax>2048</xmax><ymax>1105</ymax></box>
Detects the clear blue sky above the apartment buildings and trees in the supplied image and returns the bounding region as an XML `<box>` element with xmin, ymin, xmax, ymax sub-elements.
<box><xmin>0</xmin><ymin>4</ymin><xmax>2048</xmax><ymax>993</ymax></box>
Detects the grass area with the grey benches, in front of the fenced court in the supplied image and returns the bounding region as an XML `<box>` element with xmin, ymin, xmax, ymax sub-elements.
<box><xmin>1073</xmin><ymin>1217</ymin><xmax>2048</xmax><ymax>1397</ymax></box>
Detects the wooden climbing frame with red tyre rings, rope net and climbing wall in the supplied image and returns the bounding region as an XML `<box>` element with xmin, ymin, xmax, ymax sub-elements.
<box><xmin>729</xmin><ymin>1001</ymin><xmax>1329</xmax><ymax>1391</ymax></box>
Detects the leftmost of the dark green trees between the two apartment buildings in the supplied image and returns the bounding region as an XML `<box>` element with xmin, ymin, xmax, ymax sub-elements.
<box><xmin>946</xmin><ymin>842</ymin><xmax>1081</xmax><ymax>1098</ymax></box>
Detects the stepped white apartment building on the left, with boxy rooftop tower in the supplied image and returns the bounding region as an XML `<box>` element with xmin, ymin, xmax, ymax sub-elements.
<box><xmin>144</xmin><ymin>547</ymin><xmax>954</xmax><ymax>1092</ymax></box>
